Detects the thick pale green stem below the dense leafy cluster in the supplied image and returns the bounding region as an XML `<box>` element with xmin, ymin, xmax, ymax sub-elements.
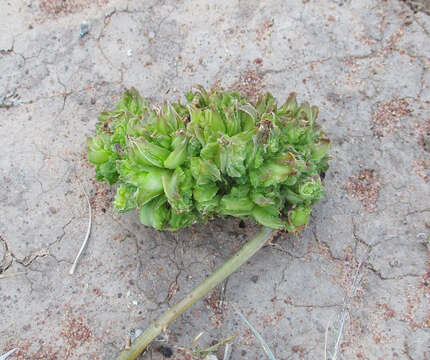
<box><xmin>117</xmin><ymin>227</ymin><xmax>273</xmax><ymax>360</ymax></box>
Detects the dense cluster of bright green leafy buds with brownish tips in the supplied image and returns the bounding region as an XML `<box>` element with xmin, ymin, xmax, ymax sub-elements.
<box><xmin>87</xmin><ymin>86</ymin><xmax>330</xmax><ymax>232</ymax></box>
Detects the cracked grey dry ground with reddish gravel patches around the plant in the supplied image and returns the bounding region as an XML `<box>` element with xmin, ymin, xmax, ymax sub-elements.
<box><xmin>0</xmin><ymin>0</ymin><xmax>430</xmax><ymax>360</ymax></box>
